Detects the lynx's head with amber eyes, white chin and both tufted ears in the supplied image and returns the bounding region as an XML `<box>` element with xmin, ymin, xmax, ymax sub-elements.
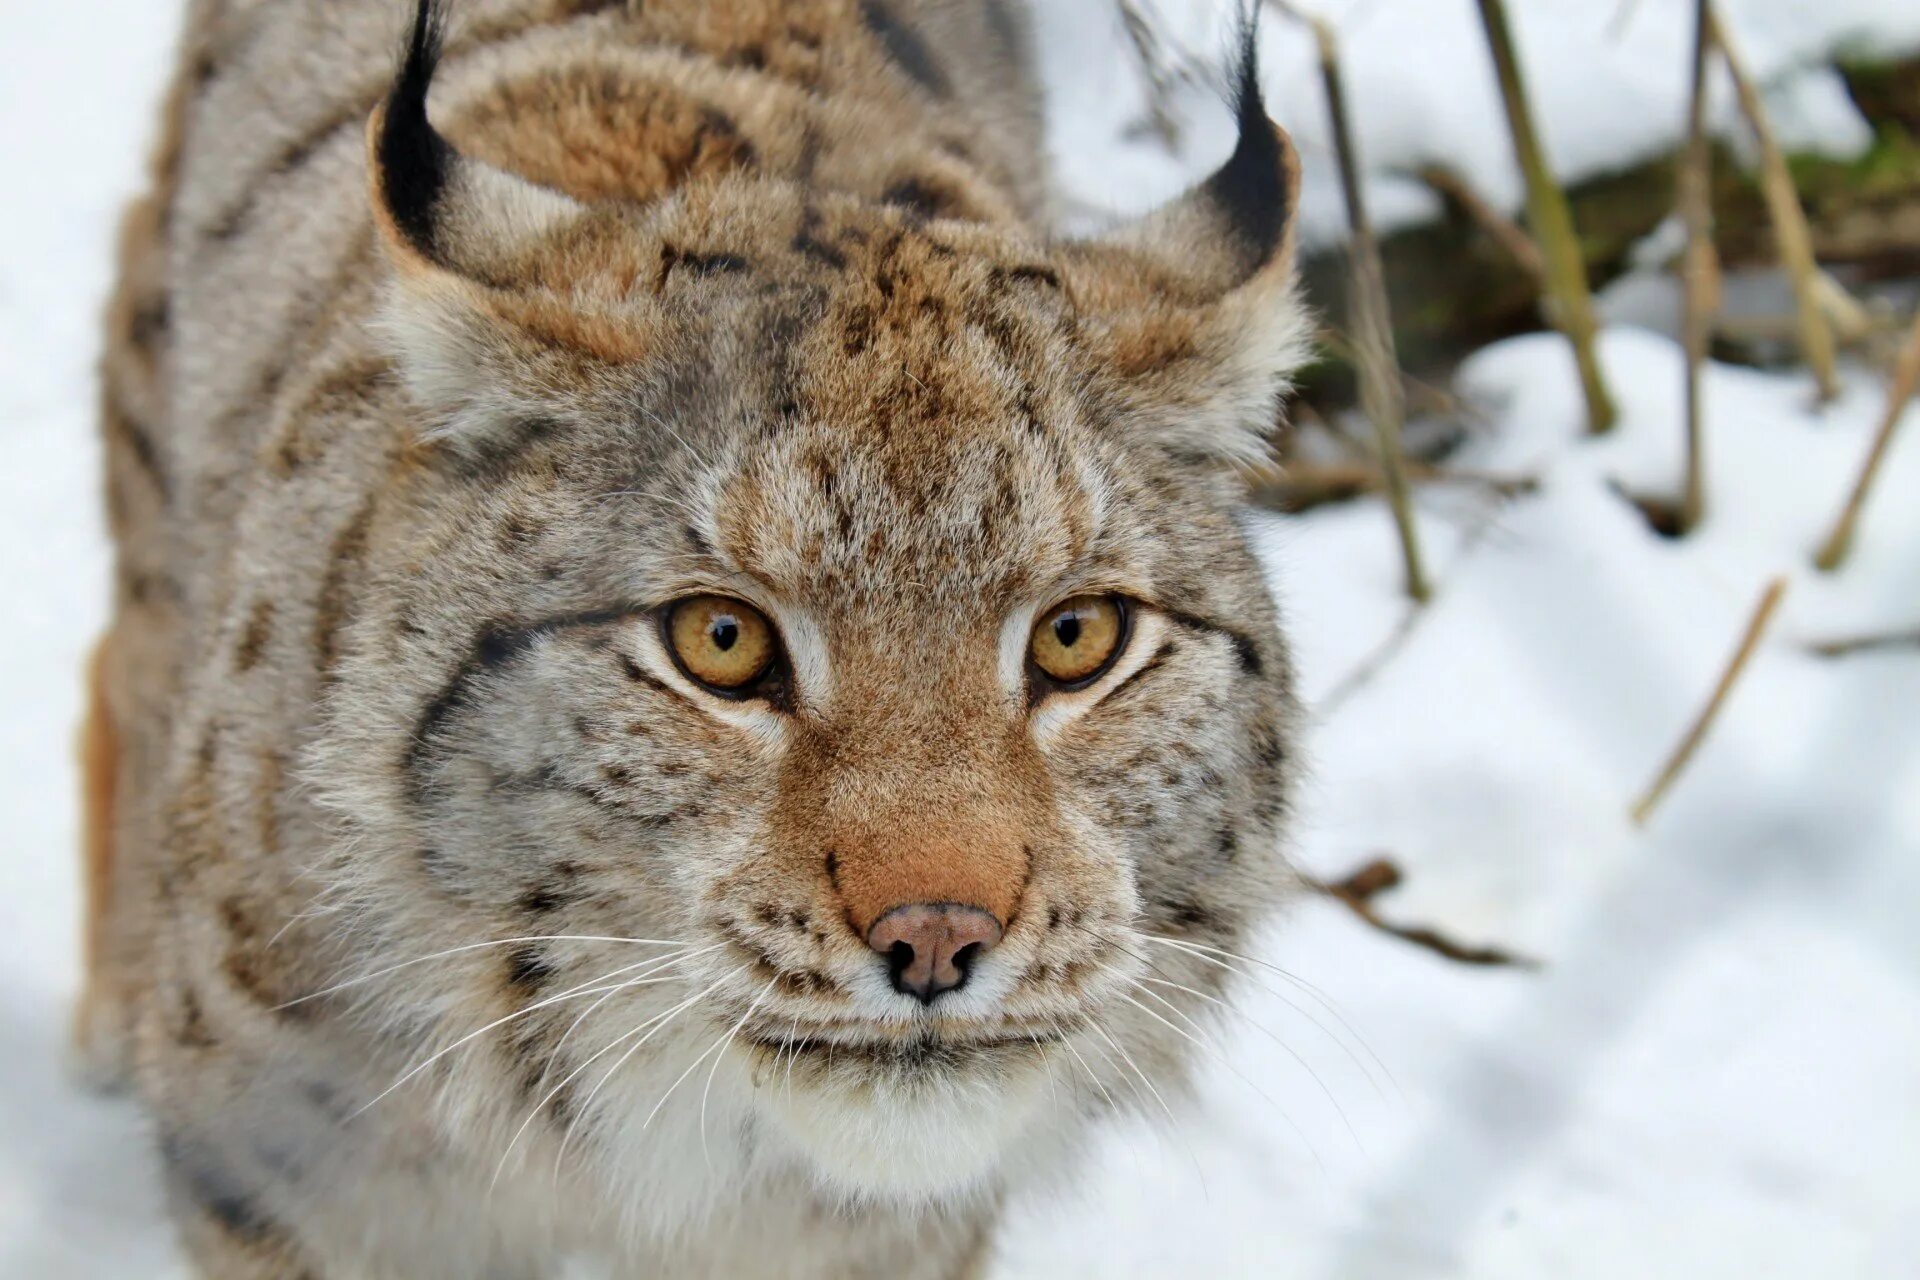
<box><xmin>328</xmin><ymin>10</ymin><xmax>1306</xmax><ymax>1197</ymax></box>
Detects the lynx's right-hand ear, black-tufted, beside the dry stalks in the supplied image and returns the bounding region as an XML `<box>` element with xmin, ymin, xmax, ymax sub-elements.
<box><xmin>1066</xmin><ymin>21</ymin><xmax>1311</xmax><ymax>462</ymax></box>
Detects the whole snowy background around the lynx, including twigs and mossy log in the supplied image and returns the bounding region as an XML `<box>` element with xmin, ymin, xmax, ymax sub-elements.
<box><xmin>0</xmin><ymin>0</ymin><xmax>1920</xmax><ymax>1280</ymax></box>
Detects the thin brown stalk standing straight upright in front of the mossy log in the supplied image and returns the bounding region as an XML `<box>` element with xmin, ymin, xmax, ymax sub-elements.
<box><xmin>1676</xmin><ymin>0</ymin><xmax>1720</xmax><ymax>533</ymax></box>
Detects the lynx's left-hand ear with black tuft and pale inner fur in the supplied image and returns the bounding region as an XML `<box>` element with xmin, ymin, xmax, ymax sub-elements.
<box><xmin>367</xmin><ymin>0</ymin><xmax>582</xmax><ymax>282</ymax></box>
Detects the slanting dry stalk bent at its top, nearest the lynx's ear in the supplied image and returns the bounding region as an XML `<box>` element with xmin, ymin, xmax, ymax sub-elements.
<box><xmin>1275</xmin><ymin>0</ymin><xmax>1432</xmax><ymax>603</ymax></box>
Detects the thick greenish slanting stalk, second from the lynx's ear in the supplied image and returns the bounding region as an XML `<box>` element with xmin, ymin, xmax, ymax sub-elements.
<box><xmin>1478</xmin><ymin>0</ymin><xmax>1617</xmax><ymax>434</ymax></box>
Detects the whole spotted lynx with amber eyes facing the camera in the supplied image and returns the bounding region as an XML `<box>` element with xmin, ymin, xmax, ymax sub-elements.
<box><xmin>79</xmin><ymin>0</ymin><xmax>1306</xmax><ymax>1278</ymax></box>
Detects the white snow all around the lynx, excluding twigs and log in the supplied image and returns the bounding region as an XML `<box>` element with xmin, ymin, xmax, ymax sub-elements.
<box><xmin>0</xmin><ymin>0</ymin><xmax>1920</xmax><ymax>1280</ymax></box>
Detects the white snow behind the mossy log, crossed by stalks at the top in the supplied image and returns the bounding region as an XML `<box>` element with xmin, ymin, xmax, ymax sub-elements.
<box><xmin>1039</xmin><ymin>0</ymin><xmax>1920</xmax><ymax>242</ymax></box>
